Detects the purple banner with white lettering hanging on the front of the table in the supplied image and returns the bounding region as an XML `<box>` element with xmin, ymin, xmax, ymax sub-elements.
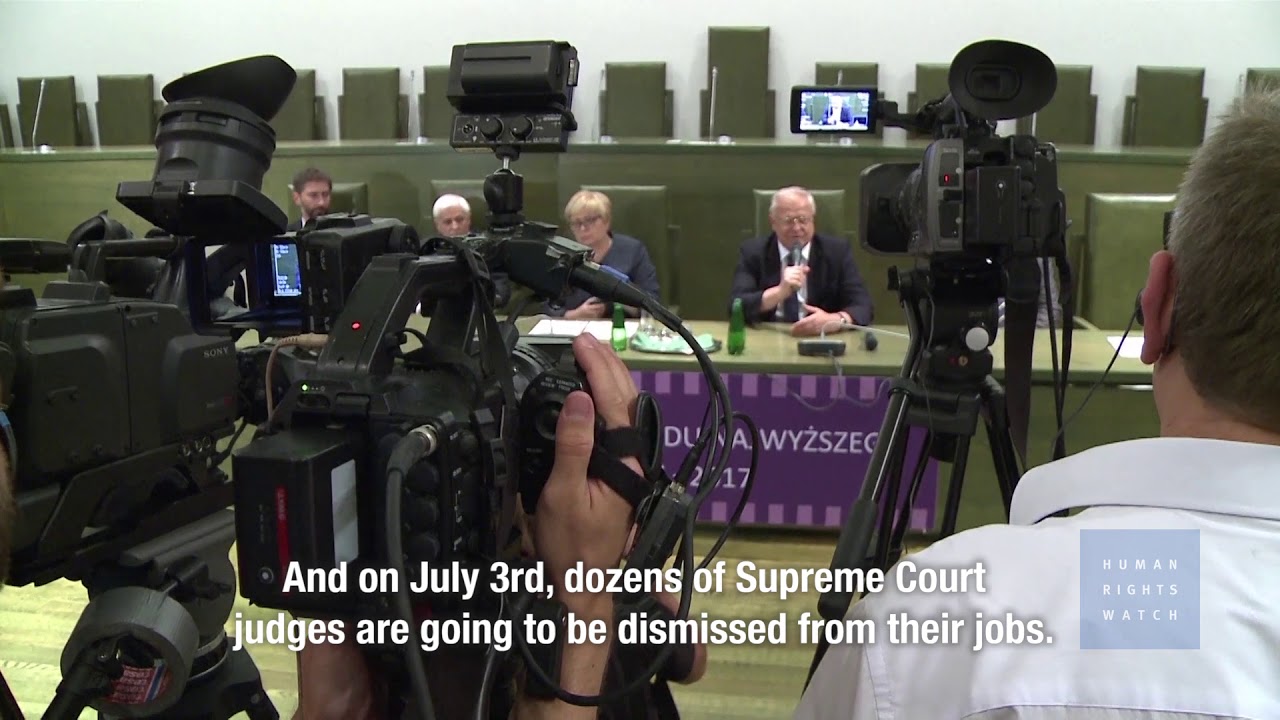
<box><xmin>631</xmin><ymin>370</ymin><xmax>938</xmax><ymax>530</ymax></box>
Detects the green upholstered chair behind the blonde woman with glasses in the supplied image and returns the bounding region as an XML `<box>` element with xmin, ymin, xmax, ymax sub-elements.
<box><xmin>582</xmin><ymin>184</ymin><xmax>680</xmax><ymax>306</ymax></box>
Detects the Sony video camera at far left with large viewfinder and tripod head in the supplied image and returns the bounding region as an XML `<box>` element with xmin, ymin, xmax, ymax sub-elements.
<box><xmin>0</xmin><ymin>58</ymin><xmax>294</xmax><ymax>720</ymax></box>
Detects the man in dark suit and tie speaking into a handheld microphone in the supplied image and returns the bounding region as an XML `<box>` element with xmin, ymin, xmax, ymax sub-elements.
<box><xmin>730</xmin><ymin>187</ymin><xmax>874</xmax><ymax>337</ymax></box>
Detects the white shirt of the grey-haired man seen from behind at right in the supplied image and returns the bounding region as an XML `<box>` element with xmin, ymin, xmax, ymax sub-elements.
<box><xmin>795</xmin><ymin>438</ymin><xmax>1280</xmax><ymax>720</ymax></box>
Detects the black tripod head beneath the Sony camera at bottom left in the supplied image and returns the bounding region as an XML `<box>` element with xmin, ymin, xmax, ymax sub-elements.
<box><xmin>44</xmin><ymin>510</ymin><xmax>279</xmax><ymax>720</ymax></box>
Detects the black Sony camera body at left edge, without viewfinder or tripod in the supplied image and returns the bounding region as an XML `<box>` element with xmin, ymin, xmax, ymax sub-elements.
<box><xmin>0</xmin><ymin>281</ymin><xmax>241</xmax><ymax>585</ymax></box>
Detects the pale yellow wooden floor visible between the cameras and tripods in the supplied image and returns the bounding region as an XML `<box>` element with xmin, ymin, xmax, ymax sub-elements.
<box><xmin>0</xmin><ymin>520</ymin><xmax>870</xmax><ymax>720</ymax></box>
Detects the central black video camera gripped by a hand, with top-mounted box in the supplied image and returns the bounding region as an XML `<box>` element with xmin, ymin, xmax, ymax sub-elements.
<box><xmin>220</xmin><ymin>42</ymin><xmax>750</xmax><ymax>717</ymax></box>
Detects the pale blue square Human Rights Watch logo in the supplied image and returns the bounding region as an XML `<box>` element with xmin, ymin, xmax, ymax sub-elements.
<box><xmin>1080</xmin><ymin>530</ymin><xmax>1201</xmax><ymax>650</ymax></box>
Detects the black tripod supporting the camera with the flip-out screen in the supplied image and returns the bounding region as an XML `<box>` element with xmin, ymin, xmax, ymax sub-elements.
<box><xmin>805</xmin><ymin>264</ymin><xmax>1020</xmax><ymax>685</ymax></box>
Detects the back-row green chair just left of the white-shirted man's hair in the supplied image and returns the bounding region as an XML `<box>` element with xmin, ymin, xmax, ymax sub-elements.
<box><xmin>1123</xmin><ymin>67</ymin><xmax>1208</xmax><ymax>147</ymax></box>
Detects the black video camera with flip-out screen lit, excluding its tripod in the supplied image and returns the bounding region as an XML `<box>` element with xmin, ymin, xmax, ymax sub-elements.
<box><xmin>859</xmin><ymin>41</ymin><xmax>1066</xmax><ymax>263</ymax></box>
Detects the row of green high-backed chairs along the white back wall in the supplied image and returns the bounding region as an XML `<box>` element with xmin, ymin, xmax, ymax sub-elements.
<box><xmin>0</xmin><ymin>45</ymin><xmax>1280</xmax><ymax>147</ymax></box>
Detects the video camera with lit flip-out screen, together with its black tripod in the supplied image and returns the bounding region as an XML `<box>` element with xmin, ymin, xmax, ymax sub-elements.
<box><xmin>810</xmin><ymin>40</ymin><xmax>1073</xmax><ymax>675</ymax></box>
